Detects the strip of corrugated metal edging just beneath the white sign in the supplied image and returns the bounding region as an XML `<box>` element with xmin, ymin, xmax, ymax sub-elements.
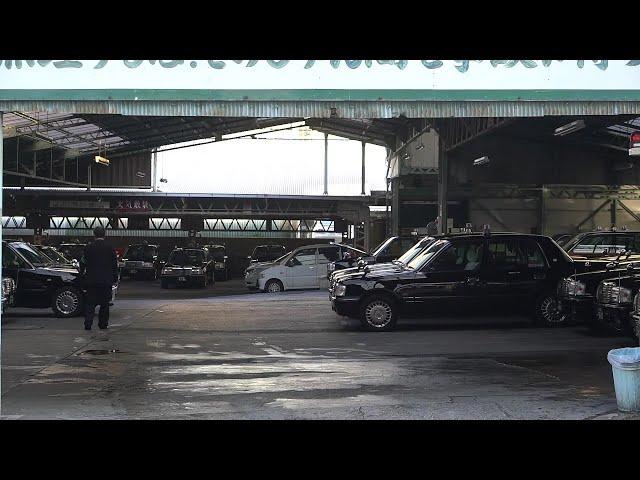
<box><xmin>0</xmin><ymin>100</ymin><xmax>640</xmax><ymax>119</ymax></box>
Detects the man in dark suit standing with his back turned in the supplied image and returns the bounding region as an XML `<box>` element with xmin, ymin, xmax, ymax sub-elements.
<box><xmin>80</xmin><ymin>227</ymin><xmax>118</xmax><ymax>330</ymax></box>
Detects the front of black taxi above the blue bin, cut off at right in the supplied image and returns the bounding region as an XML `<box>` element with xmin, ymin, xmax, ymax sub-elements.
<box><xmin>593</xmin><ymin>263</ymin><xmax>640</xmax><ymax>339</ymax></box>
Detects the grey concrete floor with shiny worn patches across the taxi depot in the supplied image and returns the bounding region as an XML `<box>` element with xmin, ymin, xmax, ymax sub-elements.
<box><xmin>0</xmin><ymin>279</ymin><xmax>638</xmax><ymax>419</ymax></box>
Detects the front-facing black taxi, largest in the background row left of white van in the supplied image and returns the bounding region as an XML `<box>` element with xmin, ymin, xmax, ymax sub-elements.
<box><xmin>160</xmin><ymin>248</ymin><xmax>215</xmax><ymax>288</ymax></box>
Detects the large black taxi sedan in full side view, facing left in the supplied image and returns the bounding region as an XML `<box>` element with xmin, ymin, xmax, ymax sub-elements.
<box><xmin>329</xmin><ymin>231</ymin><xmax>574</xmax><ymax>331</ymax></box>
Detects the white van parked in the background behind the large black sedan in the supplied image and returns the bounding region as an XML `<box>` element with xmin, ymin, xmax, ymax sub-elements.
<box><xmin>258</xmin><ymin>243</ymin><xmax>364</xmax><ymax>293</ymax></box>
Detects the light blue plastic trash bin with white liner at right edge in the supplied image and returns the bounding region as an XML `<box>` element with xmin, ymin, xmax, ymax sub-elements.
<box><xmin>607</xmin><ymin>347</ymin><xmax>640</xmax><ymax>412</ymax></box>
